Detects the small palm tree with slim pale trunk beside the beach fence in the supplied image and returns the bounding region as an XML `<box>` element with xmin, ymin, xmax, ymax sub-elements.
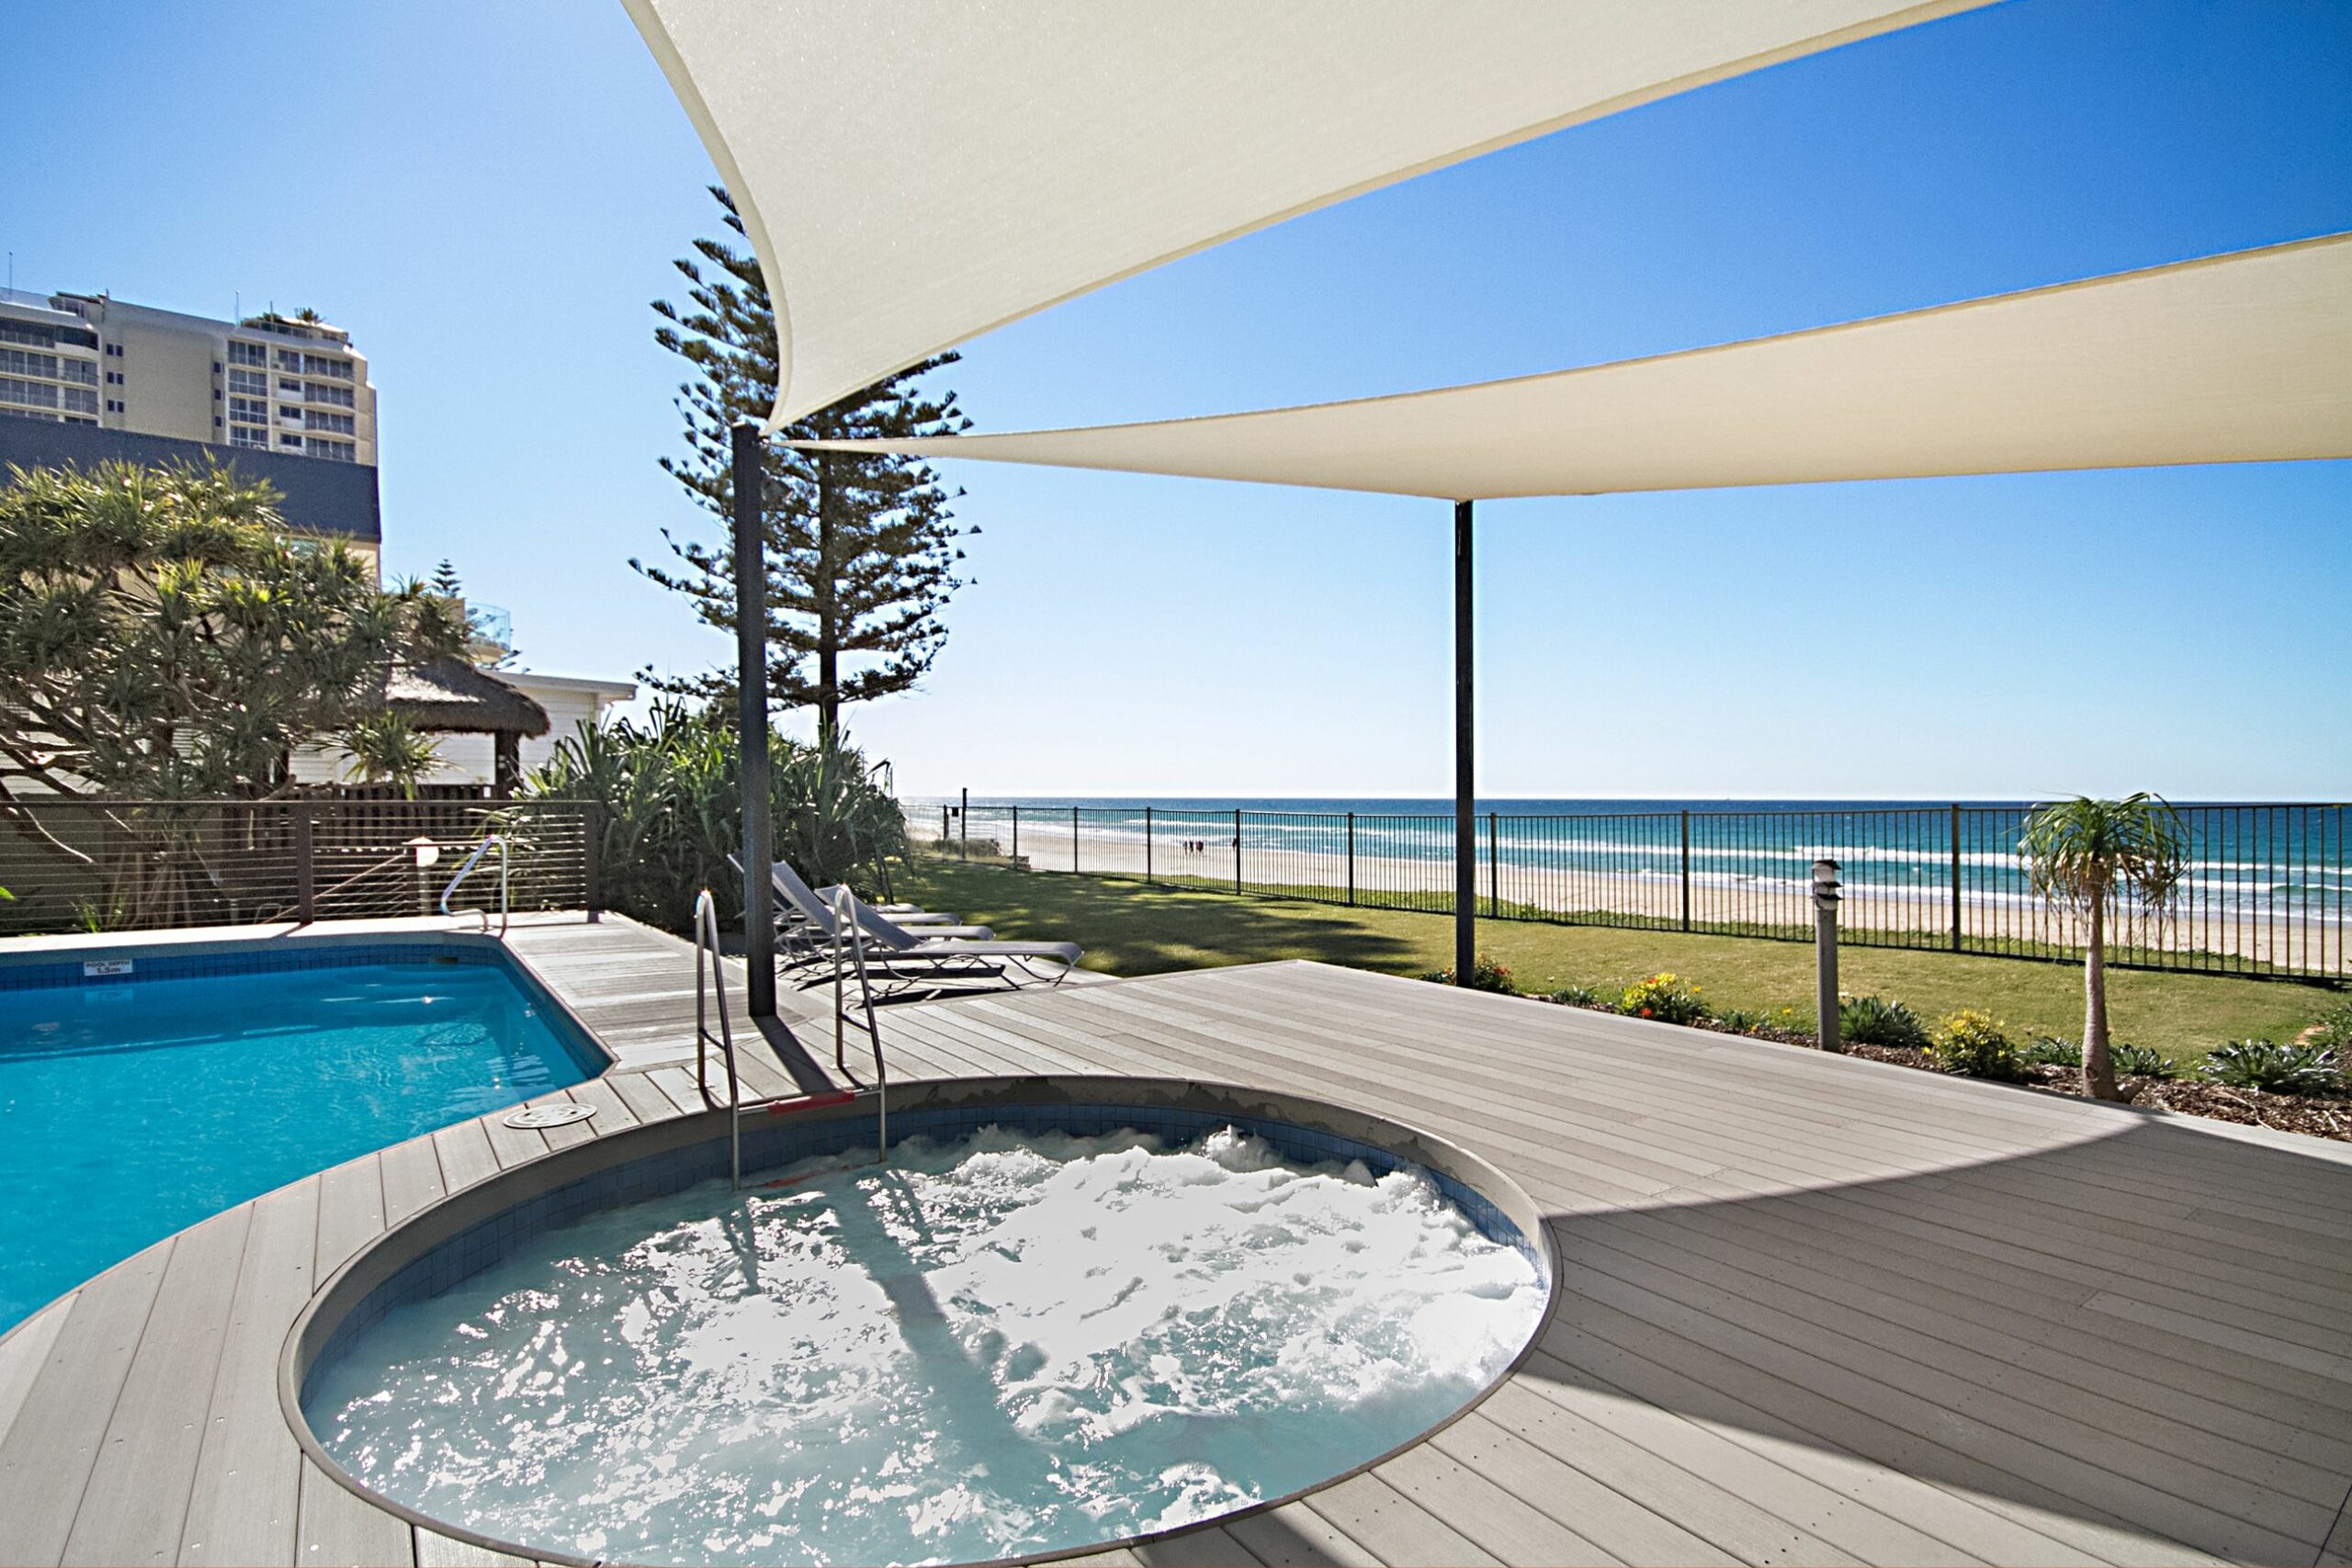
<box><xmin>2018</xmin><ymin>790</ymin><xmax>2188</xmax><ymax>1100</ymax></box>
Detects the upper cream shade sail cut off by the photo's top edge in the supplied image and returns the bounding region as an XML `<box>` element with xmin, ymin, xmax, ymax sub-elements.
<box><xmin>623</xmin><ymin>0</ymin><xmax>1983</xmax><ymax>423</ymax></box>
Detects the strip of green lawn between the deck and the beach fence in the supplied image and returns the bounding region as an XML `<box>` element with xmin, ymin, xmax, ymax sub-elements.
<box><xmin>906</xmin><ymin>861</ymin><xmax>2343</xmax><ymax>1055</ymax></box>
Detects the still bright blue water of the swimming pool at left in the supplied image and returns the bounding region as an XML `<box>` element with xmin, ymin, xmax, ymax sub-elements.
<box><xmin>0</xmin><ymin>950</ymin><xmax>602</xmax><ymax>1331</ymax></box>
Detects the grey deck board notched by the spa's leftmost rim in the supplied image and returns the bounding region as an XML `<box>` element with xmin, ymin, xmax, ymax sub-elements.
<box><xmin>176</xmin><ymin>1176</ymin><xmax>318</xmax><ymax>1568</ymax></box>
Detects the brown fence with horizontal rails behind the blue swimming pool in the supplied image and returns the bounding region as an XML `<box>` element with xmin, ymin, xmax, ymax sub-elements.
<box><xmin>0</xmin><ymin>799</ymin><xmax>600</xmax><ymax>936</ymax></box>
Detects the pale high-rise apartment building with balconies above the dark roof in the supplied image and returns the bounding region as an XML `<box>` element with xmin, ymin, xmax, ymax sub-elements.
<box><xmin>0</xmin><ymin>289</ymin><xmax>377</xmax><ymax>466</ymax></box>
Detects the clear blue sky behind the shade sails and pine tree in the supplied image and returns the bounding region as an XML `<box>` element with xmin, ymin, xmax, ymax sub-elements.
<box><xmin>0</xmin><ymin>0</ymin><xmax>2352</xmax><ymax>799</ymax></box>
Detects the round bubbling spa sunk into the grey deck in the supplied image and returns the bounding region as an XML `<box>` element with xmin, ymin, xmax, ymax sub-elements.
<box><xmin>282</xmin><ymin>1079</ymin><xmax>1553</xmax><ymax>1563</ymax></box>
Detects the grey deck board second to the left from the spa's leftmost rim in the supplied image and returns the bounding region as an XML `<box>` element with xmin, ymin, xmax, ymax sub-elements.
<box><xmin>62</xmin><ymin>1203</ymin><xmax>252</xmax><ymax>1568</ymax></box>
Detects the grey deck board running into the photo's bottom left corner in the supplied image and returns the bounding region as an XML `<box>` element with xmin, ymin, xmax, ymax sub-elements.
<box><xmin>0</xmin><ymin>1239</ymin><xmax>176</xmax><ymax>1563</ymax></box>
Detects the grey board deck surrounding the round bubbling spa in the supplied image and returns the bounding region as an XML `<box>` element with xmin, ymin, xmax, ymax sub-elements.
<box><xmin>0</xmin><ymin>907</ymin><xmax>2352</xmax><ymax>1568</ymax></box>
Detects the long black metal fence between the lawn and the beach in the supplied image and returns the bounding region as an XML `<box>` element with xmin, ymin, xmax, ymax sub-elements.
<box><xmin>908</xmin><ymin>804</ymin><xmax>2352</xmax><ymax>980</ymax></box>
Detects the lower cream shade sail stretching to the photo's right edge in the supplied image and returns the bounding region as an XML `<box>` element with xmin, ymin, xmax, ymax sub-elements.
<box><xmin>809</xmin><ymin>232</ymin><xmax>2352</xmax><ymax>501</ymax></box>
